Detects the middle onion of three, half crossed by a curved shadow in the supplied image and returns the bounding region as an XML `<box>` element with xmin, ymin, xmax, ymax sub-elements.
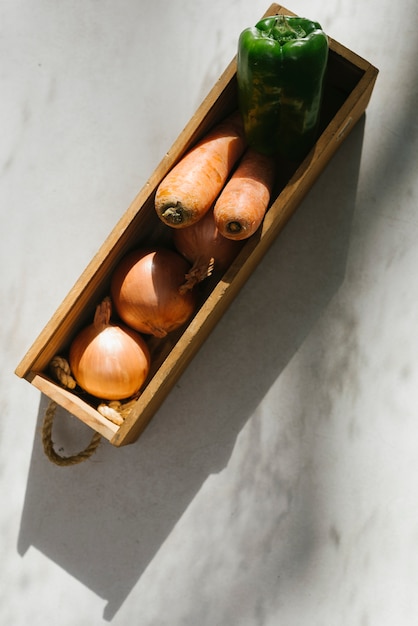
<box><xmin>111</xmin><ymin>247</ymin><xmax>196</xmax><ymax>337</ymax></box>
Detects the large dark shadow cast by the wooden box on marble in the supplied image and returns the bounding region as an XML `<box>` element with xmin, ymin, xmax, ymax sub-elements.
<box><xmin>18</xmin><ymin>117</ymin><xmax>365</xmax><ymax>621</ymax></box>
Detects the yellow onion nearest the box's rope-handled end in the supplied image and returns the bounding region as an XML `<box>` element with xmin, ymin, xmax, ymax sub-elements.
<box><xmin>69</xmin><ymin>298</ymin><xmax>150</xmax><ymax>400</ymax></box>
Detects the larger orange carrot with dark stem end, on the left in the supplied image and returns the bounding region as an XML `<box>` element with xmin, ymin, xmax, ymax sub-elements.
<box><xmin>155</xmin><ymin>113</ymin><xmax>246</xmax><ymax>228</ymax></box>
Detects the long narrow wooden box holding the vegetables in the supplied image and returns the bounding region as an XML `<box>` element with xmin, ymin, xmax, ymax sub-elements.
<box><xmin>16</xmin><ymin>4</ymin><xmax>378</xmax><ymax>446</ymax></box>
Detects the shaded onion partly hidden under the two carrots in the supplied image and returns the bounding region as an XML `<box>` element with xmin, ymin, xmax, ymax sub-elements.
<box><xmin>173</xmin><ymin>209</ymin><xmax>243</xmax><ymax>291</ymax></box>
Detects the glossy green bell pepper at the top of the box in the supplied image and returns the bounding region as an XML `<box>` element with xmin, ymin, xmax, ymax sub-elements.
<box><xmin>237</xmin><ymin>15</ymin><xmax>328</xmax><ymax>161</ymax></box>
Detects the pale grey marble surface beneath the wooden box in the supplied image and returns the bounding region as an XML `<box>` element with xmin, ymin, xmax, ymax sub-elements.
<box><xmin>0</xmin><ymin>0</ymin><xmax>418</xmax><ymax>626</ymax></box>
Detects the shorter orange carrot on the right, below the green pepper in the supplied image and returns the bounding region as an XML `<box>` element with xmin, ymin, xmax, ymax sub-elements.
<box><xmin>213</xmin><ymin>148</ymin><xmax>275</xmax><ymax>239</ymax></box>
